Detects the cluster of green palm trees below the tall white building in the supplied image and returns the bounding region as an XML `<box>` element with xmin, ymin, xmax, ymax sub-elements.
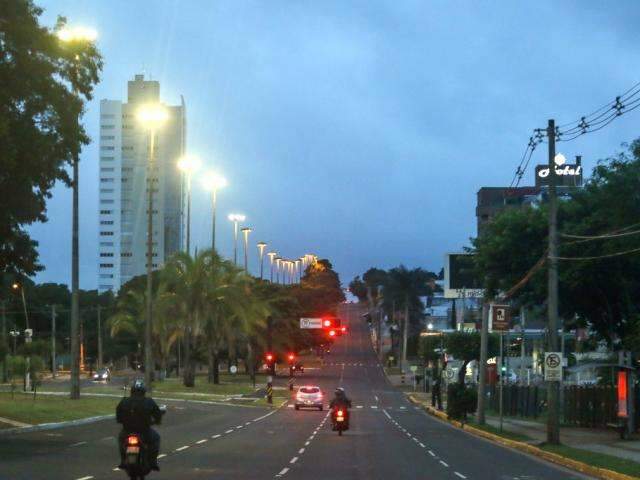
<box><xmin>109</xmin><ymin>250</ymin><xmax>278</xmax><ymax>387</ymax></box>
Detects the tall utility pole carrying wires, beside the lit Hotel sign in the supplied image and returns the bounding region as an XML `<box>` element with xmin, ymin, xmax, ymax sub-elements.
<box><xmin>547</xmin><ymin>120</ymin><xmax>560</xmax><ymax>445</ymax></box>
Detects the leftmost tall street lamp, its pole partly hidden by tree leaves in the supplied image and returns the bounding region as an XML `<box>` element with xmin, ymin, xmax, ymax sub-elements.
<box><xmin>57</xmin><ymin>26</ymin><xmax>98</xmax><ymax>399</ymax></box>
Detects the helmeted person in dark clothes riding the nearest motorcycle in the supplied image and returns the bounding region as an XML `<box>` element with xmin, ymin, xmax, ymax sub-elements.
<box><xmin>116</xmin><ymin>380</ymin><xmax>163</xmax><ymax>470</ymax></box>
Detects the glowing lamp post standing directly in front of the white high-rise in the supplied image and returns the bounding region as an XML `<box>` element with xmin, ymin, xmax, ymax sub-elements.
<box><xmin>136</xmin><ymin>103</ymin><xmax>169</xmax><ymax>390</ymax></box>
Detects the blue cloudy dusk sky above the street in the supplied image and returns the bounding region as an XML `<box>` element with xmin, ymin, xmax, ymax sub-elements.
<box><xmin>31</xmin><ymin>0</ymin><xmax>640</xmax><ymax>288</ymax></box>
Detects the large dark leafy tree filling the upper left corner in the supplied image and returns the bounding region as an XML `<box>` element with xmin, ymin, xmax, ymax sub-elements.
<box><xmin>0</xmin><ymin>0</ymin><xmax>102</xmax><ymax>275</ymax></box>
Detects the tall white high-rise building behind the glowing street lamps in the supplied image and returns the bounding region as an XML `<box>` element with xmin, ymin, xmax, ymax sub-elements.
<box><xmin>98</xmin><ymin>75</ymin><xmax>186</xmax><ymax>292</ymax></box>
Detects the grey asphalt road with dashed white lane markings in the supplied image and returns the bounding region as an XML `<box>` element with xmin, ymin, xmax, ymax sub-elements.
<box><xmin>0</xmin><ymin>306</ymin><xmax>585</xmax><ymax>480</ymax></box>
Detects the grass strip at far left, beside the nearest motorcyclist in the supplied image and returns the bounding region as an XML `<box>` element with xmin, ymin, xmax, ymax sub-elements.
<box><xmin>0</xmin><ymin>393</ymin><xmax>119</xmax><ymax>424</ymax></box>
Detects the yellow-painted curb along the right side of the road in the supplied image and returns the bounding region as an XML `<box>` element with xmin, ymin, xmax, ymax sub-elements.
<box><xmin>407</xmin><ymin>395</ymin><xmax>640</xmax><ymax>480</ymax></box>
